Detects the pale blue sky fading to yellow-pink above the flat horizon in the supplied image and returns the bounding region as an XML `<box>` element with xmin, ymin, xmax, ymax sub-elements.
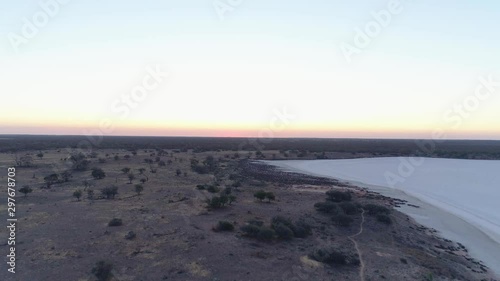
<box><xmin>0</xmin><ymin>0</ymin><xmax>500</xmax><ymax>139</ymax></box>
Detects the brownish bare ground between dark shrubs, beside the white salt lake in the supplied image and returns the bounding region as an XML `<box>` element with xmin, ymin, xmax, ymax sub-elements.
<box><xmin>0</xmin><ymin>149</ymin><xmax>493</xmax><ymax>281</ymax></box>
